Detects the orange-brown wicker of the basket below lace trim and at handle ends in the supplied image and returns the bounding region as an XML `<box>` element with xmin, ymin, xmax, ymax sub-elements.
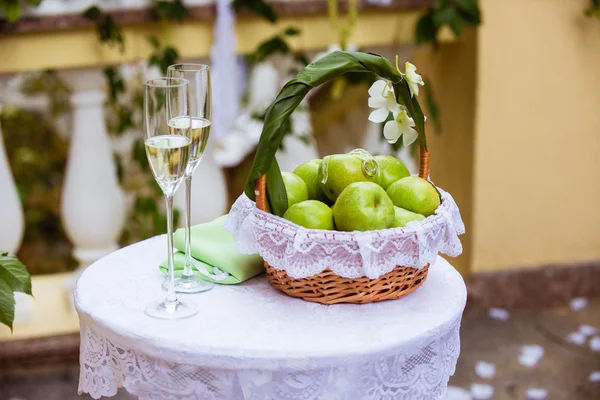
<box><xmin>255</xmin><ymin>130</ymin><xmax>429</xmax><ymax>304</ymax></box>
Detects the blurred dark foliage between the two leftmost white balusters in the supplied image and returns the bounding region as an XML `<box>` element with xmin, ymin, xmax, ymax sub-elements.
<box><xmin>0</xmin><ymin>71</ymin><xmax>76</xmax><ymax>274</ymax></box>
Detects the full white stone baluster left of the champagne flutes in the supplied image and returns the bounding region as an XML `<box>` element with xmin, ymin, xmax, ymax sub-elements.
<box><xmin>61</xmin><ymin>69</ymin><xmax>125</xmax><ymax>268</ymax></box>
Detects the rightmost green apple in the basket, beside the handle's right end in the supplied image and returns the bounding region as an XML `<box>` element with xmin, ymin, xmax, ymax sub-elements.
<box><xmin>387</xmin><ymin>176</ymin><xmax>440</xmax><ymax>217</ymax></box>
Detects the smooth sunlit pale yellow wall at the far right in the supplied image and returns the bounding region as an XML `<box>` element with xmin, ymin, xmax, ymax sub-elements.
<box><xmin>471</xmin><ymin>0</ymin><xmax>600</xmax><ymax>272</ymax></box>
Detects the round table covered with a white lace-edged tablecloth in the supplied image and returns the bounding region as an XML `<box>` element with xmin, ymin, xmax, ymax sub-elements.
<box><xmin>74</xmin><ymin>236</ymin><xmax>466</xmax><ymax>400</ymax></box>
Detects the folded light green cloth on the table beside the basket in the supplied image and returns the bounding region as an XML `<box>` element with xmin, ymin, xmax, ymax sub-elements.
<box><xmin>159</xmin><ymin>215</ymin><xmax>265</xmax><ymax>285</ymax></box>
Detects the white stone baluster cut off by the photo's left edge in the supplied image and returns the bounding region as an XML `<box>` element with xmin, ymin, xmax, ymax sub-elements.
<box><xmin>0</xmin><ymin>104</ymin><xmax>25</xmax><ymax>253</ymax></box>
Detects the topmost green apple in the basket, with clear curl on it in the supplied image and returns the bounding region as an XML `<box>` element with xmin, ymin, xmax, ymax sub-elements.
<box><xmin>319</xmin><ymin>154</ymin><xmax>376</xmax><ymax>202</ymax></box>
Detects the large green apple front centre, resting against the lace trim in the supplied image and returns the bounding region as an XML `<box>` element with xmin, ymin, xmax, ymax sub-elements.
<box><xmin>333</xmin><ymin>182</ymin><xmax>395</xmax><ymax>231</ymax></box>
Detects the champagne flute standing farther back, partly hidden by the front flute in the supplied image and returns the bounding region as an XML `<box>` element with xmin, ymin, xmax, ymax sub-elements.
<box><xmin>167</xmin><ymin>64</ymin><xmax>214</xmax><ymax>293</ymax></box>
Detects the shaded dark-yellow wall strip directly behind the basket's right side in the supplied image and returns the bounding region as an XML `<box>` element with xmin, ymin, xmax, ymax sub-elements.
<box><xmin>413</xmin><ymin>30</ymin><xmax>477</xmax><ymax>275</ymax></box>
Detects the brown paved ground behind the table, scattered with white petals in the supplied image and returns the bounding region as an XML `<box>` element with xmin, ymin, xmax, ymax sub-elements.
<box><xmin>0</xmin><ymin>299</ymin><xmax>600</xmax><ymax>400</ymax></box>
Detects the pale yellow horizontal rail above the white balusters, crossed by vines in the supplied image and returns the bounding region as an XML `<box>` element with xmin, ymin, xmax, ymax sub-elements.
<box><xmin>0</xmin><ymin>10</ymin><xmax>432</xmax><ymax>73</ymax></box>
